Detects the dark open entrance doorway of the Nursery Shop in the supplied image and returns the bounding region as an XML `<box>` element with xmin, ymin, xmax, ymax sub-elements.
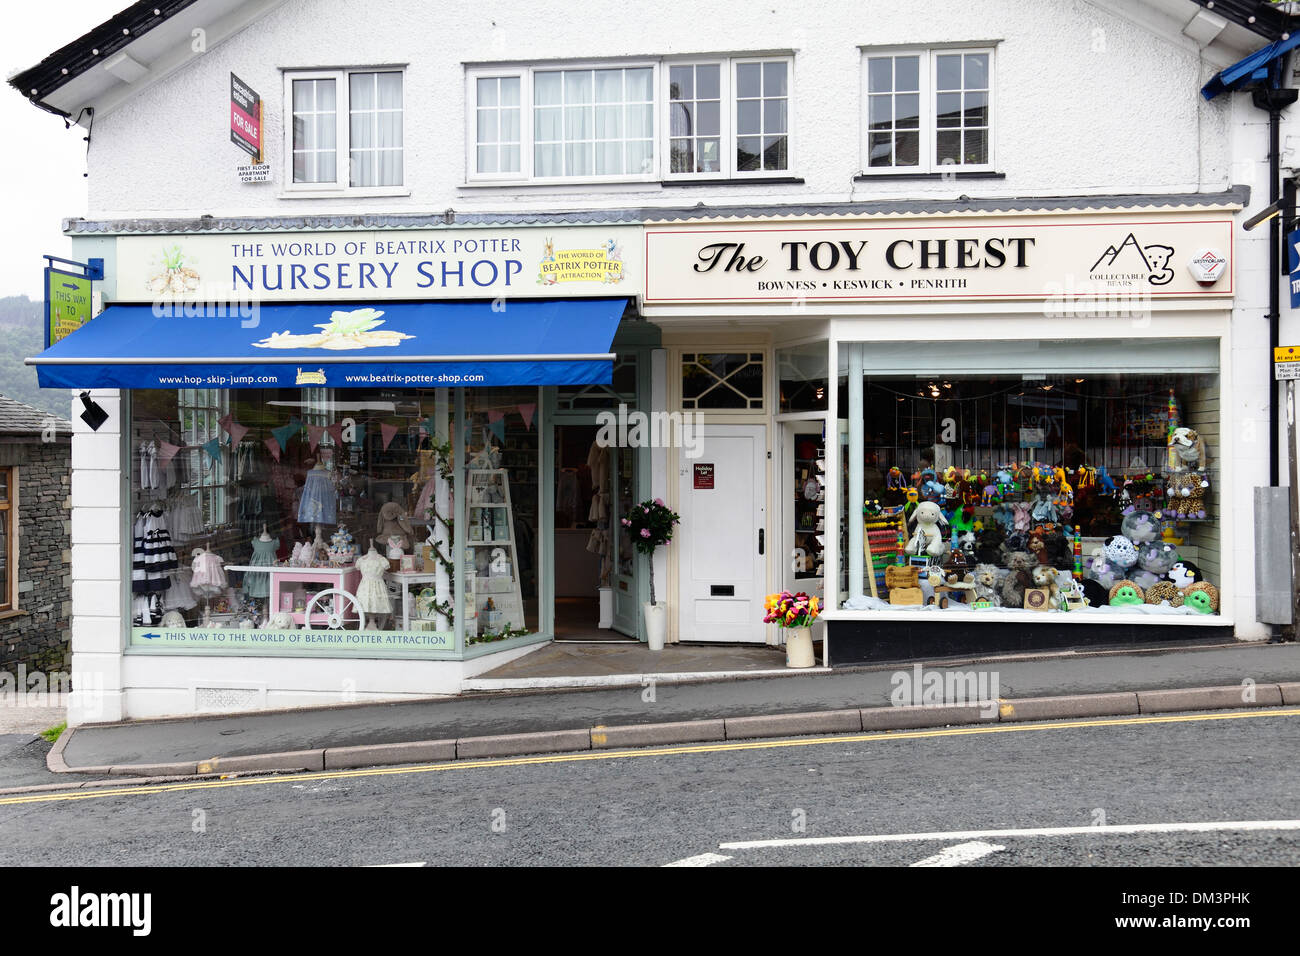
<box><xmin>551</xmin><ymin>424</ymin><xmax>636</xmax><ymax>641</ymax></box>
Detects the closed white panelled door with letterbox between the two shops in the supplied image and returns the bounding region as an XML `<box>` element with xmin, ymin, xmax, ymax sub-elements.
<box><xmin>677</xmin><ymin>425</ymin><xmax>771</xmax><ymax>643</ymax></box>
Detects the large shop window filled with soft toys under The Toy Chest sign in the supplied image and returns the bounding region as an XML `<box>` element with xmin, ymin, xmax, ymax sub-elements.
<box><xmin>839</xmin><ymin>342</ymin><xmax>1221</xmax><ymax>620</ymax></box>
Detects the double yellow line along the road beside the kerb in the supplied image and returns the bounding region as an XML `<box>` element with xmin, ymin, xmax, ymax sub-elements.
<box><xmin>0</xmin><ymin>708</ymin><xmax>1300</xmax><ymax>806</ymax></box>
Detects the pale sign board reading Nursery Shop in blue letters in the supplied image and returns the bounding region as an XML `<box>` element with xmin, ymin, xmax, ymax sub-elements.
<box><xmin>112</xmin><ymin>226</ymin><xmax>642</xmax><ymax>302</ymax></box>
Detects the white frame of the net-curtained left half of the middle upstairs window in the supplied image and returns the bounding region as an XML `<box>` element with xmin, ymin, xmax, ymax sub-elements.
<box><xmin>465</xmin><ymin>60</ymin><xmax>663</xmax><ymax>186</ymax></box>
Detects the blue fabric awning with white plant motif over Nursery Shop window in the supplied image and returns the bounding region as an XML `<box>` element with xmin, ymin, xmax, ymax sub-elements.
<box><xmin>27</xmin><ymin>299</ymin><xmax>627</xmax><ymax>389</ymax></box>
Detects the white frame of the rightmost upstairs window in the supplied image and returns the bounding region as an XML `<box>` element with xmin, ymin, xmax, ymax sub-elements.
<box><xmin>859</xmin><ymin>46</ymin><xmax>998</xmax><ymax>176</ymax></box>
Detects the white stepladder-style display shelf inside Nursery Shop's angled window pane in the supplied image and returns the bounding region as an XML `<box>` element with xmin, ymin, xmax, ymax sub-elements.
<box><xmin>464</xmin><ymin>468</ymin><xmax>524</xmax><ymax>639</ymax></box>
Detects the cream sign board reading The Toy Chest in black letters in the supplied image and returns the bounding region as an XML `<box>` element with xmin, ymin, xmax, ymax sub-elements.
<box><xmin>645</xmin><ymin>216</ymin><xmax>1232</xmax><ymax>303</ymax></box>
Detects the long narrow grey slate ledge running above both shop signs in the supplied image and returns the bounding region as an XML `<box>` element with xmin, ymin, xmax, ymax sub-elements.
<box><xmin>64</xmin><ymin>186</ymin><xmax>1251</xmax><ymax>235</ymax></box>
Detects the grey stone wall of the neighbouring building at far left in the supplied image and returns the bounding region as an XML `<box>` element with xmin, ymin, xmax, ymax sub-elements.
<box><xmin>0</xmin><ymin>436</ymin><xmax>72</xmax><ymax>675</ymax></box>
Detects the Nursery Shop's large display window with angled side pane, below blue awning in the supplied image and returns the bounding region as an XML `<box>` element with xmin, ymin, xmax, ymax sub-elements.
<box><xmin>130</xmin><ymin>389</ymin><xmax>537</xmax><ymax>657</ymax></box>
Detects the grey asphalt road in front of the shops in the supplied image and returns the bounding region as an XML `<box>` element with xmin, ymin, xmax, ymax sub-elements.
<box><xmin>0</xmin><ymin>708</ymin><xmax>1300</xmax><ymax>868</ymax></box>
